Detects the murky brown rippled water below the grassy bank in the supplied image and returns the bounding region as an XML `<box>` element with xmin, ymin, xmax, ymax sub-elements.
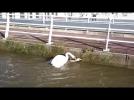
<box><xmin>0</xmin><ymin>51</ymin><xmax>134</xmax><ymax>87</ymax></box>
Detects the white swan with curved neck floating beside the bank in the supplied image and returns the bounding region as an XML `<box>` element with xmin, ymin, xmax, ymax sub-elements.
<box><xmin>51</xmin><ymin>52</ymin><xmax>76</xmax><ymax>68</ymax></box>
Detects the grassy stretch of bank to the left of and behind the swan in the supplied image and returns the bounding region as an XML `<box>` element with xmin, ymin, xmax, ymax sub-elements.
<box><xmin>0</xmin><ymin>40</ymin><xmax>64</xmax><ymax>59</ymax></box>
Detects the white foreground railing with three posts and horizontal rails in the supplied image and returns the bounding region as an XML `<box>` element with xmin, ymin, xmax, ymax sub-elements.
<box><xmin>0</xmin><ymin>15</ymin><xmax>134</xmax><ymax>51</ymax></box>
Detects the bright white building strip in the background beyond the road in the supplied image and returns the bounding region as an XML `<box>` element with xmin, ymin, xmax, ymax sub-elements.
<box><xmin>0</xmin><ymin>12</ymin><xmax>134</xmax><ymax>19</ymax></box>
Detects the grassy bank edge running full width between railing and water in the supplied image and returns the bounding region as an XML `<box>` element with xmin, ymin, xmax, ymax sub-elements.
<box><xmin>0</xmin><ymin>40</ymin><xmax>134</xmax><ymax>69</ymax></box>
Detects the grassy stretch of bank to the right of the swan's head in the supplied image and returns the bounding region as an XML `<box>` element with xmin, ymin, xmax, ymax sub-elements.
<box><xmin>81</xmin><ymin>49</ymin><xmax>131</xmax><ymax>67</ymax></box>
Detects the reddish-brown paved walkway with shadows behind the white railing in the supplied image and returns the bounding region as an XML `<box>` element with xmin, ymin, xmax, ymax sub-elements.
<box><xmin>0</xmin><ymin>28</ymin><xmax>134</xmax><ymax>55</ymax></box>
